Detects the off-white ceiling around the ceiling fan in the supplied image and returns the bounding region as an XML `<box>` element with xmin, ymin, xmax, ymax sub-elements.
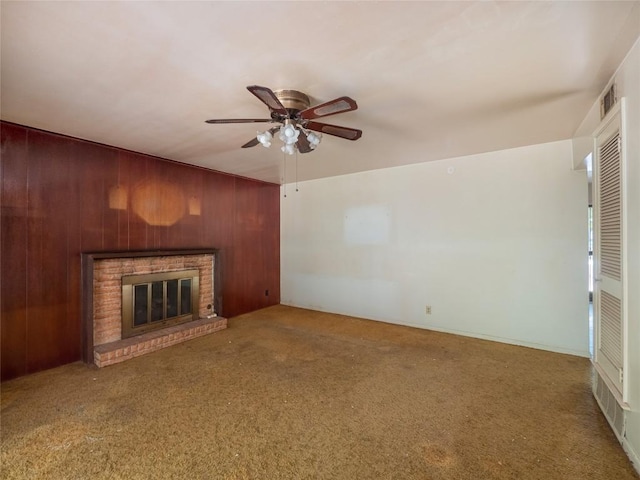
<box><xmin>0</xmin><ymin>1</ymin><xmax>640</xmax><ymax>183</ymax></box>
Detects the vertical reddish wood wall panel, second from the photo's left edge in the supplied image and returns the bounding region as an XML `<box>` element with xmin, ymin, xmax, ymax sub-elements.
<box><xmin>27</xmin><ymin>130</ymin><xmax>72</xmax><ymax>372</ymax></box>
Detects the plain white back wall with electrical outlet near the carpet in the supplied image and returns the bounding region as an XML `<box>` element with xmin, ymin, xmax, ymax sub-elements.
<box><xmin>281</xmin><ymin>140</ymin><xmax>589</xmax><ymax>356</ymax></box>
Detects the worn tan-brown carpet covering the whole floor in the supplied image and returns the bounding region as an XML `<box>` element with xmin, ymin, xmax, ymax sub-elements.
<box><xmin>1</xmin><ymin>306</ymin><xmax>638</xmax><ymax>480</ymax></box>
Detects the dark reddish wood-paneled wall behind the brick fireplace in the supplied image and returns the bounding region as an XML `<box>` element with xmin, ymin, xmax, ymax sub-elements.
<box><xmin>0</xmin><ymin>122</ymin><xmax>280</xmax><ymax>380</ymax></box>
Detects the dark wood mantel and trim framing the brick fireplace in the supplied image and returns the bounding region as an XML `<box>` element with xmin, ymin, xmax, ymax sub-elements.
<box><xmin>81</xmin><ymin>248</ymin><xmax>222</xmax><ymax>364</ymax></box>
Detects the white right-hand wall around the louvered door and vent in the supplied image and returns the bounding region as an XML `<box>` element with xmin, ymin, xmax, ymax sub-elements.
<box><xmin>576</xmin><ymin>38</ymin><xmax>640</xmax><ymax>472</ymax></box>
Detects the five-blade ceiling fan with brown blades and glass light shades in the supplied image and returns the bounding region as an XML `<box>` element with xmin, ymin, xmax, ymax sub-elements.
<box><xmin>206</xmin><ymin>85</ymin><xmax>362</xmax><ymax>155</ymax></box>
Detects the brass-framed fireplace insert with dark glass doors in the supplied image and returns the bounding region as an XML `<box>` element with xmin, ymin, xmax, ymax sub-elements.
<box><xmin>122</xmin><ymin>269</ymin><xmax>200</xmax><ymax>338</ymax></box>
